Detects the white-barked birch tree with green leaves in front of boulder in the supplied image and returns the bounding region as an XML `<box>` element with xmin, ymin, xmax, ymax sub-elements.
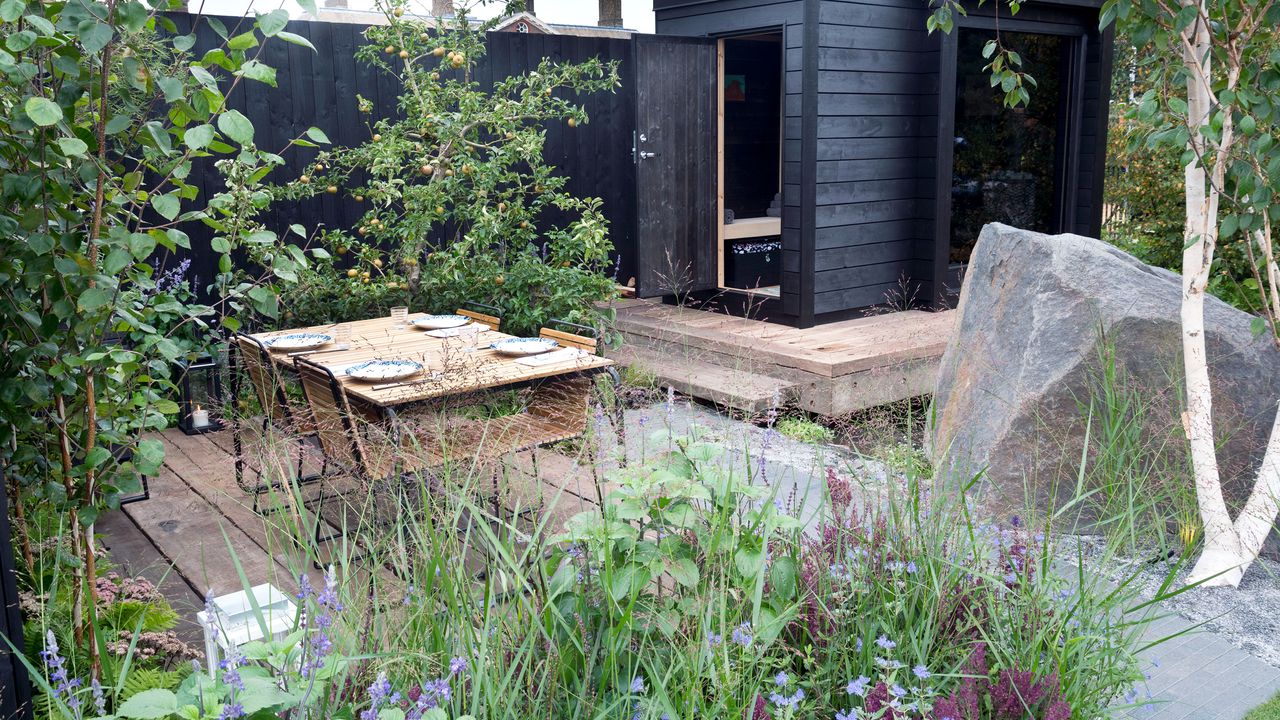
<box><xmin>929</xmin><ymin>0</ymin><xmax>1280</xmax><ymax>587</ymax></box>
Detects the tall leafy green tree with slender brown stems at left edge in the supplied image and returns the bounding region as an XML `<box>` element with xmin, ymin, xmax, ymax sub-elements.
<box><xmin>0</xmin><ymin>0</ymin><xmax>322</xmax><ymax>652</ymax></box>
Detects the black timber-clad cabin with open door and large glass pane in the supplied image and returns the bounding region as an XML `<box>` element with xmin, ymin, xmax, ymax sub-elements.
<box><xmin>632</xmin><ymin>0</ymin><xmax>1112</xmax><ymax>327</ymax></box>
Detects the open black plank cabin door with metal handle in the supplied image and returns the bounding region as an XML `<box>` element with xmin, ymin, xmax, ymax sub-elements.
<box><xmin>631</xmin><ymin>35</ymin><xmax>718</xmax><ymax>297</ymax></box>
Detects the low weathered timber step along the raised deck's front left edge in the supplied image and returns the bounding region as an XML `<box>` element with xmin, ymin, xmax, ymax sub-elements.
<box><xmin>614</xmin><ymin>345</ymin><xmax>795</xmax><ymax>413</ymax></box>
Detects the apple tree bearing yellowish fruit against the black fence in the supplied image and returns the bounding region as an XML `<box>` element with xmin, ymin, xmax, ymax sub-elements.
<box><xmin>276</xmin><ymin>1</ymin><xmax>618</xmax><ymax>334</ymax></box>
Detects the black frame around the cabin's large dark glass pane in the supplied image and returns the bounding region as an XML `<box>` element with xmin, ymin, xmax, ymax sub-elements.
<box><xmin>932</xmin><ymin>15</ymin><xmax>1089</xmax><ymax>306</ymax></box>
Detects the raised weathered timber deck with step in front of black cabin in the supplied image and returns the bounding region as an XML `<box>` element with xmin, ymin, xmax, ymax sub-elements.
<box><xmin>617</xmin><ymin>301</ymin><xmax>955</xmax><ymax>415</ymax></box>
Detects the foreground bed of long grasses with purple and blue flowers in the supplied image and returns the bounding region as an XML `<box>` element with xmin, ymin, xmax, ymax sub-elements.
<box><xmin>17</xmin><ymin>409</ymin><xmax>1162</xmax><ymax>720</ymax></box>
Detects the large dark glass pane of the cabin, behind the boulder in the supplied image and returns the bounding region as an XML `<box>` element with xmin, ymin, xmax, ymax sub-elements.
<box><xmin>950</xmin><ymin>28</ymin><xmax>1075</xmax><ymax>264</ymax></box>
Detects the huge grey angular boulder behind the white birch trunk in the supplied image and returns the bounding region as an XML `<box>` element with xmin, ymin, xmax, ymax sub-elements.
<box><xmin>931</xmin><ymin>224</ymin><xmax>1280</xmax><ymax>521</ymax></box>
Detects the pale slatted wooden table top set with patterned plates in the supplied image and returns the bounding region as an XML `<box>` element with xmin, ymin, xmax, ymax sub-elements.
<box><xmin>253</xmin><ymin>313</ymin><xmax>613</xmax><ymax>407</ymax></box>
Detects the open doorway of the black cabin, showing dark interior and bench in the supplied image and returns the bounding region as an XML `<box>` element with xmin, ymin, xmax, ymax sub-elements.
<box><xmin>718</xmin><ymin>32</ymin><xmax>783</xmax><ymax>297</ymax></box>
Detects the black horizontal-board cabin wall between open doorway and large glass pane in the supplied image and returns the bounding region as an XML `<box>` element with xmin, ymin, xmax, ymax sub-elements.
<box><xmin>814</xmin><ymin>0</ymin><xmax>938</xmax><ymax>315</ymax></box>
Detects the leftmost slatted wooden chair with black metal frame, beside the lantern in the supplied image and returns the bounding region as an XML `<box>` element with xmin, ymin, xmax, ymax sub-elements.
<box><xmin>232</xmin><ymin>333</ymin><xmax>324</xmax><ymax>512</ymax></box>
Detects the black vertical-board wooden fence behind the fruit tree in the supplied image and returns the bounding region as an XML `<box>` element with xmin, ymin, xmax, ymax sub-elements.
<box><xmin>174</xmin><ymin>15</ymin><xmax>635</xmax><ymax>294</ymax></box>
